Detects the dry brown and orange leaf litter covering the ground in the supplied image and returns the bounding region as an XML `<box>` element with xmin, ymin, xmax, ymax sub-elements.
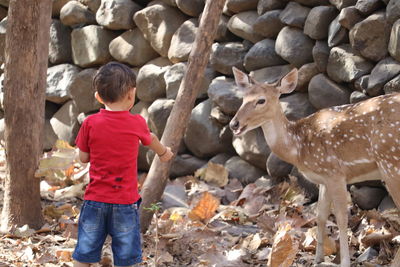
<box><xmin>0</xmin><ymin>141</ymin><xmax>400</xmax><ymax>267</ymax></box>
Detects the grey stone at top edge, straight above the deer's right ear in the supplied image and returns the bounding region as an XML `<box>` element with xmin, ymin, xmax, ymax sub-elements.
<box><xmin>279</xmin><ymin>2</ymin><xmax>311</xmax><ymax>29</ymax></box>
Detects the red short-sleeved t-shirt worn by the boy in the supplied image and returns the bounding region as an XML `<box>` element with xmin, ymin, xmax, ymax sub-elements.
<box><xmin>76</xmin><ymin>109</ymin><xmax>151</xmax><ymax>204</ymax></box>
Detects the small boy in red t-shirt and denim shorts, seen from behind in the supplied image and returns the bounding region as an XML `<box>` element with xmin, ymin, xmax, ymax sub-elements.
<box><xmin>73</xmin><ymin>62</ymin><xmax>173</xmax><ymax>267</ymax></box>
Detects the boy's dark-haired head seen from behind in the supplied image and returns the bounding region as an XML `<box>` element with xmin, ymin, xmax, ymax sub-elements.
<box><xmin>93</xmin><ymin>62</ymin><xmax>136</xmax><ymax>103</ymax></box>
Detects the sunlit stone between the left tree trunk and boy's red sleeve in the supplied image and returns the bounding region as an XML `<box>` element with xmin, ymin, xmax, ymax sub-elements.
<box><xmin>50</xmin><ymin>100</ymin><xmax>79</xmax><ymax>145</ymax></box>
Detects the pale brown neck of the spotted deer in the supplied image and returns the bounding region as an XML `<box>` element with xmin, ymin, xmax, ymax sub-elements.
<box><xmin>261</xmin><ymin>106</ymin><xmax>297</xmax><ymax>164</ymax></box>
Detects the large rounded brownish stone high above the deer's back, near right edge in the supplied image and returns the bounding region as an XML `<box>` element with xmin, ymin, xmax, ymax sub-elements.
<box><xmin>349</xmin><ymin>12</ymin><xmax>390</xmax><ymax>61</ymax></box>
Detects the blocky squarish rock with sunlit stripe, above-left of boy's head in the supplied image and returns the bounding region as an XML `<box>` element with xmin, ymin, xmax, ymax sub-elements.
<box><xmin>71</xmin><ymin>25</ymin><xmax>118</xmax><ymax>68</ymax></box>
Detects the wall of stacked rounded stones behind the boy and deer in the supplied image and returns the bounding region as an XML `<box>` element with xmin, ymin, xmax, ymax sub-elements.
<box><xmin>0</xmin><ymin>0</ymin><xmax>400</xmax><ymax>200</ymax></box>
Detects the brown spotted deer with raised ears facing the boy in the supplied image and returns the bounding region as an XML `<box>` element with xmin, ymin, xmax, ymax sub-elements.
<box><xmin>229</xmin><ymin>67</ymin><xmax>400</xmax><ymax>267</ymax></box>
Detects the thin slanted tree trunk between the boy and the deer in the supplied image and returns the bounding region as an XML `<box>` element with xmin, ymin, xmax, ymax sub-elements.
<box><xmin>140</xmin><ymin>0</ymin><xmax>225</xmax><ymax>232</ymax></box>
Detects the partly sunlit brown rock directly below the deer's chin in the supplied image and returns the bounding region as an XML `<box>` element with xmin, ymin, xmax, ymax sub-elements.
<box><xmin>232</xmin><ymin>128</ymin><xmax>271</xmax><ymax>170</ymax></box>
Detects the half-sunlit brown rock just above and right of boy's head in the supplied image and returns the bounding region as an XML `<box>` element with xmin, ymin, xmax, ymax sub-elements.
<box><xmin>110</xmin><ymin>28</ymin><xmax>158</xmax><ymax>66</ymax></box>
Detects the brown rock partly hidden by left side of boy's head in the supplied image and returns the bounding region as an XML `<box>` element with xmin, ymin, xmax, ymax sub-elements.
<box><xmin>69</xmin><ymin>68</ymin><xmax>102</xmax><ymax>113</ymax></box>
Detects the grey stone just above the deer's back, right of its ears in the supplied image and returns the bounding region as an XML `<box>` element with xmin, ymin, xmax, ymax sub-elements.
<box><xmin>308</xmin><ymin>74</ymin><xmax>350</xmax><ymax>109</ymax></box>
